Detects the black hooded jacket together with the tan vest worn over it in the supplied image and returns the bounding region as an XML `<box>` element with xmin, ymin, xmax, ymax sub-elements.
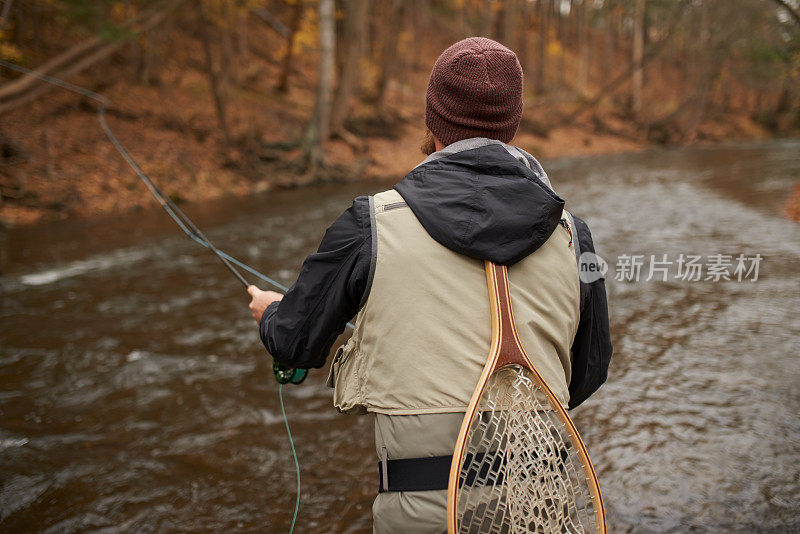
<box><xmin>261</xmin><ymin>139</ymin><xmax>612</xmax><ymax>415</ymax></box>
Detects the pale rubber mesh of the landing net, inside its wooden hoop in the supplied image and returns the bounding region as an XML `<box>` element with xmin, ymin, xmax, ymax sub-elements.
<box><xmin>456</xmin><ymin>365</ymin><xmax>597</xmax><ymax>534</ymax></box>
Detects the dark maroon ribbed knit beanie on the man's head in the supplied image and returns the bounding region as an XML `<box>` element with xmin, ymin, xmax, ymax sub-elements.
<box><xmin>425</xmin><ymin>37</ymin><xmax>522</xmax><ymax>145</ymax></box>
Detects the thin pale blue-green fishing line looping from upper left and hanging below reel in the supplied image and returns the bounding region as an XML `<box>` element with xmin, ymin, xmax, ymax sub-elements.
<box><xmin>0</xmin><ymin>59</ymin><xmax>354</xmax><ymax>534</ymax></box>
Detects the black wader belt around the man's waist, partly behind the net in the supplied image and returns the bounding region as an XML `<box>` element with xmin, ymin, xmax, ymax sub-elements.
<box><xmin>378</xmin><ymin>449</ymin><xmax>503</xmax><ymax>493</ymax></box>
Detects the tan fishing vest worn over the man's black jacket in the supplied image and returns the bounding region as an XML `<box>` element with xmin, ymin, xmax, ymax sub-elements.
<box><xmin>328</xmin><ymin>190</ymin><xmax>580</xmax><ymax>415</ymax></box>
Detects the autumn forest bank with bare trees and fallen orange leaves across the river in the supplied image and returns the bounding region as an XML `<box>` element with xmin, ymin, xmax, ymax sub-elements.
<box><xmin>0</xmin><ymin>0</ymin><xmax>800</xmax><ymax>225</ymax></box>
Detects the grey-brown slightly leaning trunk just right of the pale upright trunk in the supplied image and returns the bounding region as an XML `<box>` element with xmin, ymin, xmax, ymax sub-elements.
<box><xmin>331</xmin><ymin>0</ymin><xmax>367</xmax><ymax>137</ymax></box>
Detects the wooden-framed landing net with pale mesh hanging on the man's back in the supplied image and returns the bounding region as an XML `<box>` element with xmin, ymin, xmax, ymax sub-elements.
<box><xmin>447</xmin><ymin>262</ymin><xmax>605</xmax><ymax>534</ymax></box>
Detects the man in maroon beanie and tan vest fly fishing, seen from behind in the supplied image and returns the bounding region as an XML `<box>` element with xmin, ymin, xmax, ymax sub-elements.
<box><xmin>248</xmin><ymin>37</ymin><xmax>612</xmax><ymax>534</ymax></box>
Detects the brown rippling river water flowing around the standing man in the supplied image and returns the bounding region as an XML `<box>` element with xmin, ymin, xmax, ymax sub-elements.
<box><xmin>0</xmin><ymin>140</ymin><xmax>800</xmax><ymax>533</ymax></box>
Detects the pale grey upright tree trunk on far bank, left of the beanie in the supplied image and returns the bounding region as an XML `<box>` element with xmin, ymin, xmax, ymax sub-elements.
<box><xmin>304</xmin><ymin>0</ymin><xmax>336</xmax><ymax>176</ymax></box>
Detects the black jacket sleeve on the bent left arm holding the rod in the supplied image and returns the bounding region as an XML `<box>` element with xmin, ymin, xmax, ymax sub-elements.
<box><xmin>259</xmin><ymin>197</ymin><xmax>372</xmax><ymax>369</ymax></box>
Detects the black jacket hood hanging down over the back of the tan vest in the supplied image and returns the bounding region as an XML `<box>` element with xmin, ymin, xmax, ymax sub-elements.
<box><xmin>394</xmin><ymin>144</ymin><xmax>564</xmax><ymax>265</ymax></box>
